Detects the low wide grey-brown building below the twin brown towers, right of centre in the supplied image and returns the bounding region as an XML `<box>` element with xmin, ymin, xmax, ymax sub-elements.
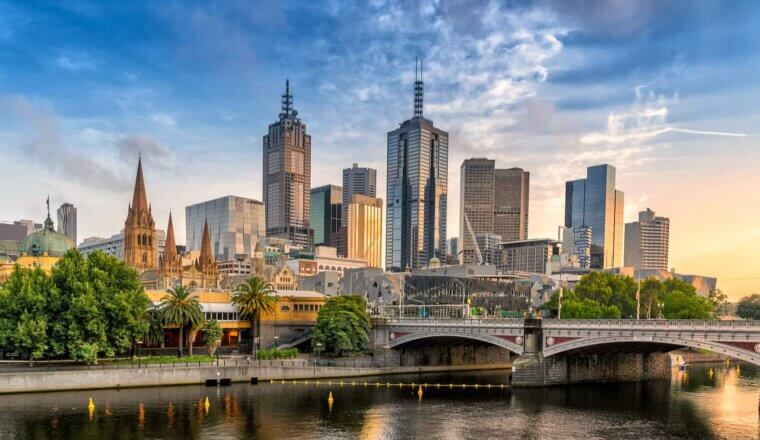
<box><xmin>497</xmin><ymin>238</ymin><xmax>559</xmax><ymax>275</ymax></box>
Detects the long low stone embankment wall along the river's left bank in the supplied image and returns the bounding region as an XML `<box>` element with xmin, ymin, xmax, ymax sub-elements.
<box><xmin>0</xmin><ymin>364</ymin><xmax>511</xmax><ymax>394</ymax></box>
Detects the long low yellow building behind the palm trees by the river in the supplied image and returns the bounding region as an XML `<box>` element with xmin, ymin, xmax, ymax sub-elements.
<box><xmin>145</xmin><ymin>290</ymin><xmax>327</xmax><ymax>352</ymax></box>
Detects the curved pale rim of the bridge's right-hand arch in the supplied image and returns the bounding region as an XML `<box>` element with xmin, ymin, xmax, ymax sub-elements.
<box><xmin>543</xmin><ymin>336</ymin><xmax>760</xmax><ymax>366</ymax></box>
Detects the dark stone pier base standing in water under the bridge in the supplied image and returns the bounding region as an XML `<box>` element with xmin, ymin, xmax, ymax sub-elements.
<box><xmin>512</xmin><ymin>353</ymin><xmax>670</xmax><ymax>386</ymax></box>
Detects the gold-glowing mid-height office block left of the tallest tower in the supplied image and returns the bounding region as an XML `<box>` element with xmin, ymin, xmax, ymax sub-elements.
<box><xmin>346</xmin><ymin>194</ymin><xmax>383</xmax><ymax>267</ymax></box>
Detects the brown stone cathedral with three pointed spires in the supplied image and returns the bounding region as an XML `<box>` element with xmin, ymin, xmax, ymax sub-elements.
<box><xmin>124</xmin><ymin>158</ymin><xmax>219</xmax><ymax>289</ymax></box>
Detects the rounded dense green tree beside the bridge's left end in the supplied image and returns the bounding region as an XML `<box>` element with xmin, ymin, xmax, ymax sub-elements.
<box><xmin>311</xmin><ymin>295</ymin><xmax>372</xmax><ymax>356</ymax></box>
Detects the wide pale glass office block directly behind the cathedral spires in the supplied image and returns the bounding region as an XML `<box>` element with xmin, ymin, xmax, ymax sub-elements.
<box><xmin>185</xmin><ymin>196</ymin><xmax>266</xmax><ymax>261</ymax></box>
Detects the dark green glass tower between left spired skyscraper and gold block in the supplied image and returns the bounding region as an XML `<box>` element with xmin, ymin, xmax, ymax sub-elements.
<box><xmin>309</xmin><ymin>185</ymin><xmax>343</xmax><ymax>245</ymax></box>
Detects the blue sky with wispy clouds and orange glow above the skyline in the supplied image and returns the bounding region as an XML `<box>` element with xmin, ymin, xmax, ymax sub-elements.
<box><xmin>0</xmin><ymin>0</ymin><xmax>760</xmax><ymax>299</ymax></box>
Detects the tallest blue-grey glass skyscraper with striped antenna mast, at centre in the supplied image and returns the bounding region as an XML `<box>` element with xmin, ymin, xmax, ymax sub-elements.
<box><xmin>385</xmin><ymin>59</ymin><xmax>449</xmax><ymax>271</ymax></box>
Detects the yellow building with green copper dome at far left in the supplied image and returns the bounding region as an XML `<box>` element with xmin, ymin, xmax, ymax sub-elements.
<box><xmin>0</xmin><ymin>202</ymin><xmax>74</xmax><ymax>283</ymax></box>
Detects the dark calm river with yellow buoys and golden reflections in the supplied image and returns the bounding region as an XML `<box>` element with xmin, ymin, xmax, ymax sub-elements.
<box><xmin>0</xmin><ymin>363</ymin><xmax>760</xmax><ymax>440</ymax></box>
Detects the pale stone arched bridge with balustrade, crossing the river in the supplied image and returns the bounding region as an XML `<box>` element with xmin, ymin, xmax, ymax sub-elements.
<box><xmin>373</xmin><ymin>306</ymin><xmax>760</xmax><ymax>385</ymax></box>
